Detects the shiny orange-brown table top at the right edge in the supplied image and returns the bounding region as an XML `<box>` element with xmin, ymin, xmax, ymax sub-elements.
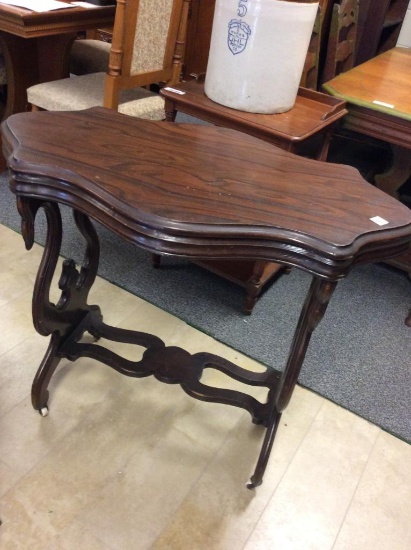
<box><xmin>323</xmin><ymin>47</ymin><xmax>411</xmax><ymax>121</ymax></box>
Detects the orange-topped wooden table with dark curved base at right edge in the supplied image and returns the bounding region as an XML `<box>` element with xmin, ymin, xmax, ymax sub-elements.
<box><xmin>324</xmin><ymin>47</ymin><xmax>411</xmax><ymax>280</ymax></box>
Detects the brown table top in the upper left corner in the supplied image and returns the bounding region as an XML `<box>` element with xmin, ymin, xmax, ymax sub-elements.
<box><xmin>0</xmin><ymin>2</ymin><xmax>115</xmax><ymax>38</ymax></box>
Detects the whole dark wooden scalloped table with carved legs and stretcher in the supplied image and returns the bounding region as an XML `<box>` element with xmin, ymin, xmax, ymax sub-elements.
<box><xmin>2</xmin><ymin>108</ymin><xmax>411</xmax><ymax>488</ymax></box>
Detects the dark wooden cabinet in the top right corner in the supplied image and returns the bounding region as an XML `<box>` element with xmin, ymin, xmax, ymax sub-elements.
<box><xmin>356</xmin><ymin>0</ymin><xmax>409</xmax><ymax>65</ymax></box>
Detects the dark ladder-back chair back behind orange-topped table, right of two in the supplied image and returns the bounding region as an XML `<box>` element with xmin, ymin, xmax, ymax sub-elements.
<box><xmin>321</xmin><ymin>0</ymin><xmax>359</xmax><ymax>83</ymax></box>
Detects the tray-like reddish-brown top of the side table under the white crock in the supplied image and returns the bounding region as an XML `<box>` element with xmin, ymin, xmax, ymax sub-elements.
<box><xmin>161</xmin><ymin>80</ymin><xmax>347</xmax><ymax>141</ymax></box>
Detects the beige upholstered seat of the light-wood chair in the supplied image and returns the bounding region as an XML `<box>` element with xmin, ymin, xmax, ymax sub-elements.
<box><xmin>27</xmin><ymin>73</ymin><xmax>165</xmax><ymax>120</ymax></box>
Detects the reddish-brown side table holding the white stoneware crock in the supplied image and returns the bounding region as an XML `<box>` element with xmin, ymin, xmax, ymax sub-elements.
<box><xmin>161</xmin><ymin>80</ymin><xmax>347</xmax><ymax>314</ymax></box>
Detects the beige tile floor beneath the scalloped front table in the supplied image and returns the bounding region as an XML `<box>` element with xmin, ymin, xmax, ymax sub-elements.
<box><xmin>0</xmin><ymin>226</ymin><xmax>411</xmax><ymax>550</ymax></box>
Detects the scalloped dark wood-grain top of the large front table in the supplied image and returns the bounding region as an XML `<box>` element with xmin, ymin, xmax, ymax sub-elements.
<box><xmin>2</xmin><ymin>108</ymin><xmax>411</xmax><ymax>280</ymax></box>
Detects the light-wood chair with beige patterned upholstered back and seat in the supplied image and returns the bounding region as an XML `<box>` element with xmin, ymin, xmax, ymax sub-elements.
<box><xmin>27</xmin><ymin>0</ymin><xmax>188</xmax><ymax>120</ymax></box>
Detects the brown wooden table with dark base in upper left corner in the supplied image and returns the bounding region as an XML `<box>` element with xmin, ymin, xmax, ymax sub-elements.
<box><xmin>0</xmin><ymin>0</ymin><xmax>115</xmax><ymax>169</ymax></box>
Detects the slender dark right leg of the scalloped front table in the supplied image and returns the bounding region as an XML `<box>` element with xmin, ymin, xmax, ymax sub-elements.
<box><xmin>247</xmin><ymin>277</ymin><xmax>337</xmax><ymax>489</ymax></box>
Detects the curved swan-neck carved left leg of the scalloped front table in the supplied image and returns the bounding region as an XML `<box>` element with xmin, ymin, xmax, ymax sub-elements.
<box><xmin>18</xmin><ymin>198</ymin><xmax>100</xmax><ymax>413</ymax></box>
